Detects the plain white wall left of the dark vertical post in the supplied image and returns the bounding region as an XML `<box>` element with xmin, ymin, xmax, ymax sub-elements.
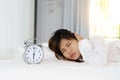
<box><xmin>0</xmin><ymin>0</ymin><xmax>34</xmax><ymax>59</ymax></box>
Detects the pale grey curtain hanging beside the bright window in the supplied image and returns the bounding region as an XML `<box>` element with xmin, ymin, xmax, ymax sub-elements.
<box><xmin>63</xmin><ymin>0</ymin><xmax>89</xmax><ymax>37</ymax></box>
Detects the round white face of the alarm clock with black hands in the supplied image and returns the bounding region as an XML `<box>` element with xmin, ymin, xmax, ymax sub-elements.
<box><xmin>24</xmin><ymin>45</ymin><xmax>43</xmax><ymax>63</ymax></box>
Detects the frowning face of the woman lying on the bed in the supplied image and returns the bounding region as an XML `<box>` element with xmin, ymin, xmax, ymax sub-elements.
<box><xmin>59</xmin><ymin>39</ymin><xmax>80</xmax><ymax>60</ymax></box>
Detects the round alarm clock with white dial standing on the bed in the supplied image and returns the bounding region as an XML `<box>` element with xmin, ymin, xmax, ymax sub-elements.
<box><xmin>23</xmin><ymin>40</ymin><xmax>44</xmax><ymax>64</ymax></box>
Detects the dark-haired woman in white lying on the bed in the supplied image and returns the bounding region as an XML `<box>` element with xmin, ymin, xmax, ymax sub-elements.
<box><xmin>49</xmin><ymin>29</ymin><xmax>120</xmax><ymax>64</ymax></box>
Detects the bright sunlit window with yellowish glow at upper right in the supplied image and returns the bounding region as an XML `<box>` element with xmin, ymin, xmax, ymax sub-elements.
<box><xmin>89</xmin><ymin>0</ymin><xmax>120</xmax><ymax>40</ymax></box>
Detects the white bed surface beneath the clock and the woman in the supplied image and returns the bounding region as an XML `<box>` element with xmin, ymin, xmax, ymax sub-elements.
<box><xmin>0</xmin><ymin>43</ymin><xmax>120</xmax><ymax>80</ymax></box>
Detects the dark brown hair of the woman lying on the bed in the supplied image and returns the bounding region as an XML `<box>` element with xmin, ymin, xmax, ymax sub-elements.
<box><xmin>48</xmin><ymin>29</ymin><xmax>77</xmax><ymax>60</ymax></box>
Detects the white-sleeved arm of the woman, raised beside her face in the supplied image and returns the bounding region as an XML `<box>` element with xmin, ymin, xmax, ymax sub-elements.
<box><xmin>79</xmin><ymin>39</ymin><xmax>107</xmax><ymax>64</ymax></box>
